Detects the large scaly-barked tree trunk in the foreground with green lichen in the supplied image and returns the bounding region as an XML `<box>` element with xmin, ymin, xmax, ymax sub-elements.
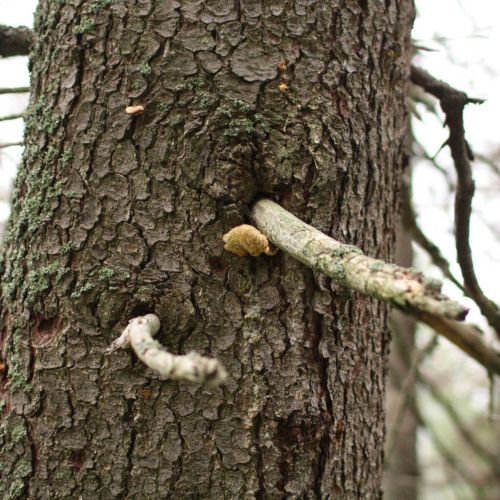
<box><xmin>0</xmin><ymin>0</ymin><xmax>413</xmax><ymax>499</ymax></box>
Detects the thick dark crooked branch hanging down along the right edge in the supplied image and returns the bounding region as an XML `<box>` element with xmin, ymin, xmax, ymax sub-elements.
<box><xmin>411</xmin><ymin>66</ymin><xmax>500</xmax><ymax>336</ymax></box>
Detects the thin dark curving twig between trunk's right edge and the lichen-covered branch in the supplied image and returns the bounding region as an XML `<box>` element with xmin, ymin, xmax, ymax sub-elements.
<box><xmin>401</xmin><ymin>183</ymin><xmax>467</xmax><ymax>294</ymax></box>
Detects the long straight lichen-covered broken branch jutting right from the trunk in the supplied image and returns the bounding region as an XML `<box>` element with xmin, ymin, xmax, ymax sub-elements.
<box><xmin>252</xmin><ymin>199</ymin><xmax>467</xmax><ymax>320</ymax></box>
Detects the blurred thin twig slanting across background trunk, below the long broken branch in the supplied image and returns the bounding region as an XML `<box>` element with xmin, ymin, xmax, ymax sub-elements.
<box><xmin>386</xmin><ymin>335</ymin><xmax>438</xmax><ymax>463</ymax></box>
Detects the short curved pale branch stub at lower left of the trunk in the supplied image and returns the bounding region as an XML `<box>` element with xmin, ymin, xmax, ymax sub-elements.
<box><xmin>107</xmin><ymin>314</ymin><xmax>227</xmax><ymax>386</ymax></box>
